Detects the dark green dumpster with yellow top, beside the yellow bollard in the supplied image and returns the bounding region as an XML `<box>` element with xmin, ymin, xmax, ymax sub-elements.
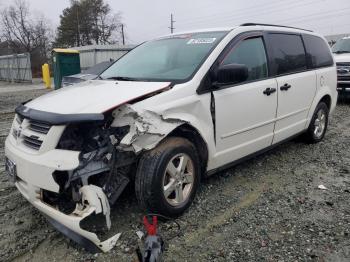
<box><xmin>52</xmin><ymin>48</ymin><xmax>80</xmax><ymax>89</ymax></box>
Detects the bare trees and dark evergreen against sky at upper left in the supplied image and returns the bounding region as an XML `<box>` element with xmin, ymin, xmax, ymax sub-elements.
<box><xmin>0</xmin><ymin>0</ymin><xmax>122</xmax><ymax>73</ymax></box>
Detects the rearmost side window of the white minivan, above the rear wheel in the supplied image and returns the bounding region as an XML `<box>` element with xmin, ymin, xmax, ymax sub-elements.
<box><xmin>303</xmin><ymin>35</ymin><xmax>333</xmax><ymax>68</ymax></box>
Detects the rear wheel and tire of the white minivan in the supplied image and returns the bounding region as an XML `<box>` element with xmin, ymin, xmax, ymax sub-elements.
<box><xmin>304</xmin><ymin>102</ymin><xmax>329</xmax><ymax>144</ymax></box>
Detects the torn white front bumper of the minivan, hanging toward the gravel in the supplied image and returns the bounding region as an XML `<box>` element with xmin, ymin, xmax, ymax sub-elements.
<box><xmin>5</xmin><ymin>136</ymin><xmax>121</xmax><ymax>253</ymax></box>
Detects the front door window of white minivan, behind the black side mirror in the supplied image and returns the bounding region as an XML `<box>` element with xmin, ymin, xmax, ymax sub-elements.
<box><xmin>221</xmin><ymin>37</ymin><xmax>267</xmax><ymax>81</ymax></box>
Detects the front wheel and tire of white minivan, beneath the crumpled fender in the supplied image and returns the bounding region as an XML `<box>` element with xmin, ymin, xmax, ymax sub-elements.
<box><xmin>135</xmin><ymin>137</ymin><xmax>201</xmax><ymax>217</ymax></box>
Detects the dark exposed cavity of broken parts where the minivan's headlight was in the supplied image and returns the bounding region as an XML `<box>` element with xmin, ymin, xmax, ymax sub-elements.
<box><xmin>48</xmin><ymin>118</ymin><xmax>135</xmax><ymax>207</ymax></box>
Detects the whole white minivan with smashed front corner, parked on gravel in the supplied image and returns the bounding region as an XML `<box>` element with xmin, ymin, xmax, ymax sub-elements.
<box><xmin>5</xmin><ymin>24</ymin><xmax>337</xmax><ymax>252</ymax></box>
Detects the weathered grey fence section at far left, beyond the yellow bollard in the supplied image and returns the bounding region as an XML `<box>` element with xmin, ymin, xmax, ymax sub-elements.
<box><xmin>0</xmin><ymin>53</ymin><xmax>32</xmax><ymax>82</ymax></box>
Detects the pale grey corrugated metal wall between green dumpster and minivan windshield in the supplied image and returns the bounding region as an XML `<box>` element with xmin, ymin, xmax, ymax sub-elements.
<box><xmin>72</xmin><ymin>45</ymin><xmax>134</xmax><ymax>70</ymax></box>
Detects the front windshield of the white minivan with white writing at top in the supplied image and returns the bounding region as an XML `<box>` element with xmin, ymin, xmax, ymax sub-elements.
<box><xmin>100</xmin><ymin>32</ymin><xmax>227</xmax><ymax>81</ymax></box>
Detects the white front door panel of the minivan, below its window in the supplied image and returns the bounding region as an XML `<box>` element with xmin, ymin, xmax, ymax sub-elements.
<box><xmin>213</xmin><ymin>79</ymin><xmax>277</xmax><ymax>165</ymax></box>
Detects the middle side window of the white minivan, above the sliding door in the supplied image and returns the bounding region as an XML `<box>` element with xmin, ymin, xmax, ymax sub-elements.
<box><xmin>269</xmin><ymin>33</ymin><xmax>307</xmax><ymax>75</ymax></box>
